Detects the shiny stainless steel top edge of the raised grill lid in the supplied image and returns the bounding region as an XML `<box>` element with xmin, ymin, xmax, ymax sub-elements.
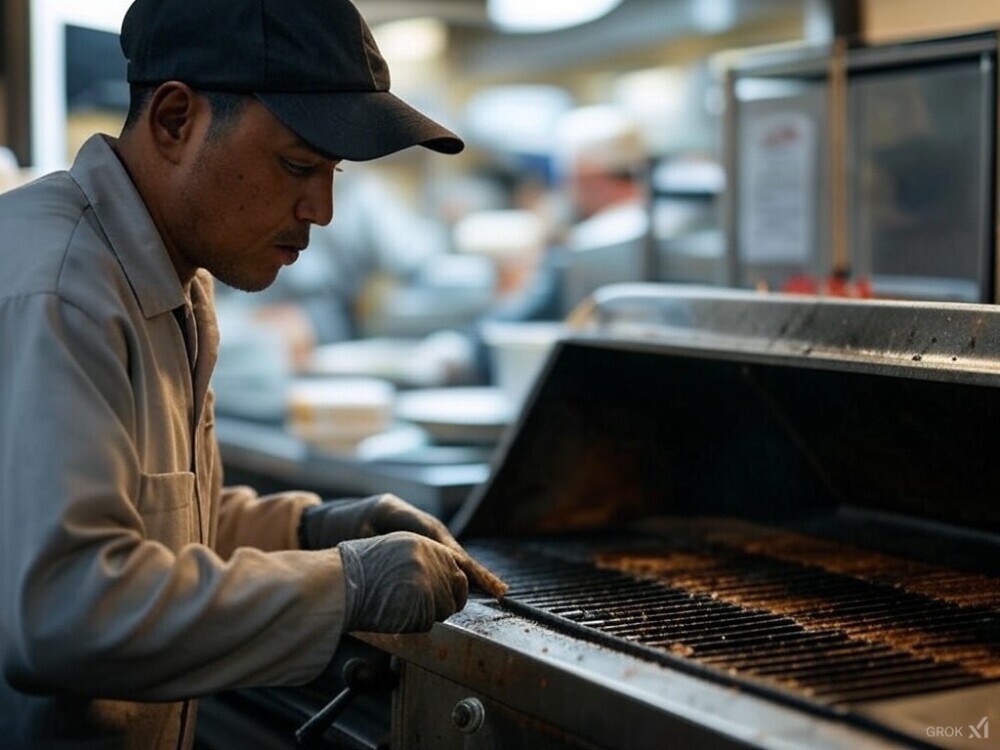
<box><xmin>586</xmin><ymin>284</ymin><xmax>1000</xmax><ymax>374</ymax></box>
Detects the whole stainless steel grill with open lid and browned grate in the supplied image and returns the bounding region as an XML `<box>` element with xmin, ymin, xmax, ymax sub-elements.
<box><xmin>363</xmin><ymin>286</ymin><xmax>1000</xmax><ymax>750</ymax></box>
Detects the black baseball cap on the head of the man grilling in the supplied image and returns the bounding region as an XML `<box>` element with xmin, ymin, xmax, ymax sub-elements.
<box><xmin>121</xmin><ymin>0</ymin><xmax>465</xmax><ymax>161</ymax></box>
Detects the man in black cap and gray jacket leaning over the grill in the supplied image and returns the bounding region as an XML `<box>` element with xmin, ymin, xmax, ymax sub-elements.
<box><xmin>0</xmin><ymin>0</ymin><xmax>500</xmax><ymax>750</ymax></box>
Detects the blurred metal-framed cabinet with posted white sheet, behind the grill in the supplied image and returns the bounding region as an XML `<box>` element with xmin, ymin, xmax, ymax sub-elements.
<box><xmin>726</xmin><ymin>32</ymin><xmax>997</xmax><ymax>302</ymax></box>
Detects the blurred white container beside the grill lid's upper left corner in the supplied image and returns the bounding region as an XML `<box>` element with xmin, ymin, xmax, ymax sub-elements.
<box><xmin>483</xmin><ymin>321</ymin><xmax>566</xmax><ymax>409</ymax></box>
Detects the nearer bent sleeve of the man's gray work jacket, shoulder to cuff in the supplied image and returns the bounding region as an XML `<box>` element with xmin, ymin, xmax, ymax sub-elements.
<box><xmin>0</xmin><ymin>294</ymin><xmax>344</xmax><ymax>701</ymax></box>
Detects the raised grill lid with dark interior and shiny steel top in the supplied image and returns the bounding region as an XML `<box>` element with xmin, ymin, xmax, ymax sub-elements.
<box><xmin>453</xmin><ymin>285</ymin><xmax>1000</xmax><ymax>544</ymax></box>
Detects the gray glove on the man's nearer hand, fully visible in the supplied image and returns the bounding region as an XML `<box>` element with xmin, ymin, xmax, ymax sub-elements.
<box><xmin>337</xmin><ymin>531</ymin><xmax>469</xmax><ymax>633</ymax></box>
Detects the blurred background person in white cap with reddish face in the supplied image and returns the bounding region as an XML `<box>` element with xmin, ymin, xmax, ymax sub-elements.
<box><xmin>456</xmin><ymin>105</ymin><xmax>650</xmax><ymax>382</ymax></box>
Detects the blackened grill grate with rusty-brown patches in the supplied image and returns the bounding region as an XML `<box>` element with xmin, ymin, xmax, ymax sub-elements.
<box><xmin>470</xmin><ymin>537</ymin><xmax>1000</xmax><ymax>706</ymax></box>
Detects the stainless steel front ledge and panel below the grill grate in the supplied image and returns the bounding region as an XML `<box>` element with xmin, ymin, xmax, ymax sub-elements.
<box><xmin>360</xmin><ymin>600</ymin><xmax>912</xmax><ymax>750</ymax></box>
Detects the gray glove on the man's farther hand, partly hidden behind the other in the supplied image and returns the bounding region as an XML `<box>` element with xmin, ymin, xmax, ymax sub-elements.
<box><xmin>299</xmin><ymin>494</ymin><xmax>461</xmax><ymax>549</ymax></box>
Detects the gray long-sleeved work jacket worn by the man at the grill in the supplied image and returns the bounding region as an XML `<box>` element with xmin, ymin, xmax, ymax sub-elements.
<box><xmin>0</xmin><ymin>136</ymin><xmax>344</xmax><ymax>750</ymax></box>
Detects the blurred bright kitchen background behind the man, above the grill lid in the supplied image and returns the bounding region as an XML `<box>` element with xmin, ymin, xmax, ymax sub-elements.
<box><xmin>0</xmin><ymin>0</ymin><xmax>1000</xmax><ymax>462</ymax></box>
